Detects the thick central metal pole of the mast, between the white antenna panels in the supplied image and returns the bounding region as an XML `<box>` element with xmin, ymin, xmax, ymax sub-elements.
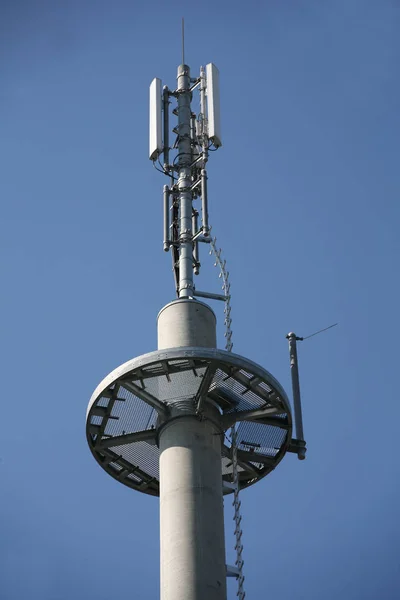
<box><xmin>177</xmin><ymin>64</ymin><xmax>193</xmax><ymax>298</ymax></box>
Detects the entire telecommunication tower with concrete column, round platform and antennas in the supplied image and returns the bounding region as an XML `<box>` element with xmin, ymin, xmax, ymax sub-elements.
<box><xmin>87</xmin><ymin>50</ymin><xmax>306</xmax><ymax>600</ymax></box>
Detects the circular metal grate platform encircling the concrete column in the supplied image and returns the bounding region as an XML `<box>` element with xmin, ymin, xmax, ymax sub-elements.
<box><xmin>86</xmin><ymin>347</ymin><xmax>292</xmax><ymax>496</ymax></box>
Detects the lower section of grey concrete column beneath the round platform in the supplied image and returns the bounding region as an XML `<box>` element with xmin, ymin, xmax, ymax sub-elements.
<box><xmin>160</xmin><ymin>416</ymin><xmax>226</xmax><ymax>600</ymax></box>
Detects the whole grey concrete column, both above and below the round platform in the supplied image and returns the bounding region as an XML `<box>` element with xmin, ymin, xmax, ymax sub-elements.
<box><xmin>158</xmin><ymin>300</ymin><xmax>226</xmax><ymax>600</ymax></box>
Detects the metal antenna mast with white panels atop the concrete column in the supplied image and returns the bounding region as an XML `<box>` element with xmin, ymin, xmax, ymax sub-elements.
<box><xmin>153</xmin><ymin>61</ymin><xmax>223</xmax><ymax>302</ymax></box>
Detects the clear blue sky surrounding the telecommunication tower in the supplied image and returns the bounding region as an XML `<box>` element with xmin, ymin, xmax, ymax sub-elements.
<box><xmin>0</xmin><ymin>0</ymin><xmax>400</xmax><ymax>600</ymax></box>
